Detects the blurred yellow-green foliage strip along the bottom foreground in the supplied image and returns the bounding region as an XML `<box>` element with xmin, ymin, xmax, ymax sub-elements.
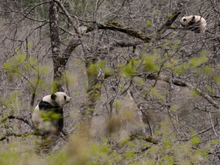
<box><xmin>0</xmin><ymin>117</ymin><xmax>211</xmax><ymax>165</ymax></box>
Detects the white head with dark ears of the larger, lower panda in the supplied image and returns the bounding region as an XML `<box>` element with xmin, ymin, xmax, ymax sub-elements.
<box><xmin>42</xmin><ymin>92</ymin><xmax>71</xmax><ymax>107</ymax></box>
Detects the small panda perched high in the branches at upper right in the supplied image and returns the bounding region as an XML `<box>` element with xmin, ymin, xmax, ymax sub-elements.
<box><xmin>180</xmin><ymin>15</ymin><xmax>207</xmax><ymax>33</ymax></box>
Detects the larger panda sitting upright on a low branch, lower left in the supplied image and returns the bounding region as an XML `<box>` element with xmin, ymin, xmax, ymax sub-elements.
<box><xmin>32</xmin><ymin>92</ymin><xmax>71</xmax><ymax>134</ymax></box>
